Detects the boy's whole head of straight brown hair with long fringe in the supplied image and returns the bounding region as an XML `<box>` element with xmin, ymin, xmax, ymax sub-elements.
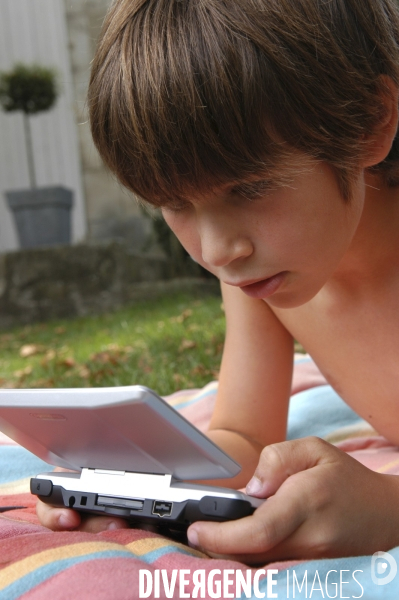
<box><xmin>89</xmin><ymin>0</ymin><xmax>399</xmax><ymax>206</ymax></box>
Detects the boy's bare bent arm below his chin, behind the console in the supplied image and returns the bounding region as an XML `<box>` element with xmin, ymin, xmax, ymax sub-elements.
<box><xmin>203</xmin><ymin>284</ymin><xmax>293</xmax><ymax>488</ymax></box>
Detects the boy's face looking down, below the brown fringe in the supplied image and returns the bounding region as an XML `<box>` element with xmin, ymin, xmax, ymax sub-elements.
<box><xmin>163</xmin><ymin>161</ymin><xmax>364</xmax><ymax>308</ymax></box>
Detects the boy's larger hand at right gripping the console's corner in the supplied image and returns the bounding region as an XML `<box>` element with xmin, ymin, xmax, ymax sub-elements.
<box><xmin>188</xmin><ymin>437</ymin><xmax>399</xmax><ymax>564</ymax></box>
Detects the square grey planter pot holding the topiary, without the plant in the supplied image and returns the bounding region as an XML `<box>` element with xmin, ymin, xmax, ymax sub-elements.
<box><xmin>5</xmin><ymin>186</ymin><xmax>73</xmax><ymax>248</ymax></box>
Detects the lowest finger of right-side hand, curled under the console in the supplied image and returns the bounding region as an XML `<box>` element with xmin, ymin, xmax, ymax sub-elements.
<box><xmin>187</xmin><ymin>494</ymin><xmax>307</xmax><ymax>560</ymax></box>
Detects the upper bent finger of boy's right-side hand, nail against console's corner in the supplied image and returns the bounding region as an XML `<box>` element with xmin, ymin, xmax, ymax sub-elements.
<box><xmin>246</xmin><ymin>437</ymin><xmax>339</xmax><ymax>498</ymax></box>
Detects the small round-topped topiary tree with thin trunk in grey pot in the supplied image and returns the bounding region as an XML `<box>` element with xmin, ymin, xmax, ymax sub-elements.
<box><xmin>0</xmin><ymin>64</ymin><xmax>73</xmax><ymax>248</ymax></box>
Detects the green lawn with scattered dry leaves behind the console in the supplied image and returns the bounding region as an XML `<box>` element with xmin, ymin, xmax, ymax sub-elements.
<box><xmin>0</xmin><ymin>294</ymin><xmax>225</xmax><ymax>394</ymax></box>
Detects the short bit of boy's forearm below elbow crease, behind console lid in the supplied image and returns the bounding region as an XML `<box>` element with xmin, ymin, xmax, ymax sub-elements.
<box><xmin>198</xmin><ymin>429</ymin><xmax>263</xmax><ymax>489</ymax></box>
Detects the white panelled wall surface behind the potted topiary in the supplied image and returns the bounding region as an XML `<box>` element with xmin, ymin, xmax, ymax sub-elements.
<box><xmin>0</xmin><ymin>0</ymin><xmax>86</xmax><ymax>252</ymax></box>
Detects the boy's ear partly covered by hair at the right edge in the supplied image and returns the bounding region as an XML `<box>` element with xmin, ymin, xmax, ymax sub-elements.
<box><xmin>363</xmin><ymin>75</ymin><xmax>399</xmax><ymax>168</ymax></box>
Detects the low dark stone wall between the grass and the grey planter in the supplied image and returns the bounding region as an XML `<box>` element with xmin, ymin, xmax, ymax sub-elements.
<box><xmin>0</xmin><ymin>243</ymin><xmax>218</xmax><ymax>329</ymax></box>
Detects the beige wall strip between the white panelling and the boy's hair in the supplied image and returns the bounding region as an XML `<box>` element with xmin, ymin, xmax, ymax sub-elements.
<box><xmin>64</xmin><ymin>0</ymin><xmax>148</xmax><ymax>251</ymax></box>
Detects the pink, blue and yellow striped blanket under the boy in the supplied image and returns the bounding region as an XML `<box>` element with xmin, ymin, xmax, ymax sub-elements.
<box><xmin>0</xmin><ymin>357</ymin><xmax>399</xmax><ymax>600</ymax></box>
